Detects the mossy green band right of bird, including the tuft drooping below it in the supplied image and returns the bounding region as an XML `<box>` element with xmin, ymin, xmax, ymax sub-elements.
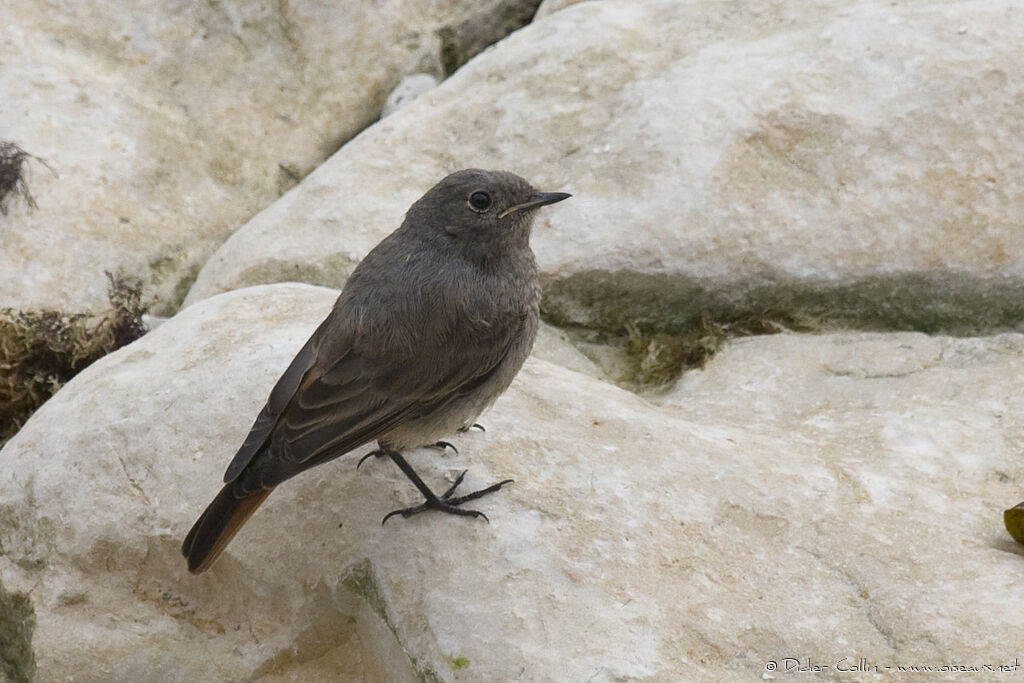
<box><xmin>541</xmin><ymin>270</ymin><xmax>1024</xmax><ymax>390</ymax></box>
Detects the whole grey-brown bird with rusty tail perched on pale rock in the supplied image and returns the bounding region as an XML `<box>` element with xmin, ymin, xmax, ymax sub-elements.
<box><xmin>181</xmin><ymin>169</ymin><xmax>569</xmax><ymax>573</ymax></box>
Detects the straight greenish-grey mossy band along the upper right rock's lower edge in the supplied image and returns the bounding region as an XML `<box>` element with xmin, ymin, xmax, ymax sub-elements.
<box><xmin>542</xmin><ymin>270</ymin><xmax>1024</xmax><ymax>336</ymax></box>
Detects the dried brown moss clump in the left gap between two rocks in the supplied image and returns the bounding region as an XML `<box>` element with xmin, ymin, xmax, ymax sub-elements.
<box><xmin>0</xmin><ymin>272</ymin><xmax>145</xmax><ymax>445</ymax></box>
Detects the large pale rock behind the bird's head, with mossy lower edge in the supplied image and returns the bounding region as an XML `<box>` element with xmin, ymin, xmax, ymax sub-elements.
<box><xmin>187</xmin><ymin>0</ymin><xmax>1024</xmax><ymax>331</ymax></box>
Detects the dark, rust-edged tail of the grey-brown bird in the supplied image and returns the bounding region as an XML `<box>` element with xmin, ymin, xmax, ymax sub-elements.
<box><xmin>181</xmin><ymin>482</ymin><xmax>273</xmax><ymax>573</ymax></box>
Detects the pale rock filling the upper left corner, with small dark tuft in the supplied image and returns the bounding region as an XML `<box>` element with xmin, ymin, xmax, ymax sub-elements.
<box><xmin>0</xmin><ymin>0</ymin><xmax>537</xmax><ymax>311</ymax></box>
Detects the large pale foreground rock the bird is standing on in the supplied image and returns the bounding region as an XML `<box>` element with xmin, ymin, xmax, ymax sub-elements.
<box><xmin>0</xmin><ymin>282</ymin><xmax>1024</xmax><ymax>681</ymax></box>
